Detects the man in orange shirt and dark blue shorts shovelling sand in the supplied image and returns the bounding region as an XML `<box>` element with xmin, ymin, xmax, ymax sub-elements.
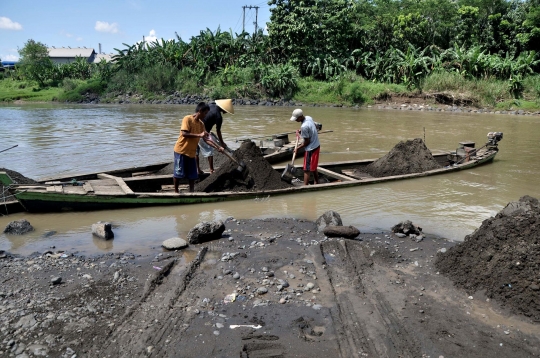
<box><xmin>173</xmin><ymin>102</ymin><xmax>223</xmax><ymax>193</ymax></box>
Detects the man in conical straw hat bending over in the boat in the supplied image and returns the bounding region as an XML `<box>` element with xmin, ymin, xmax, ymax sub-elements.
<box><xmin>197</xmin><ymin>99</ymin><xmax>234</xmax><ymax>175</ymax></box>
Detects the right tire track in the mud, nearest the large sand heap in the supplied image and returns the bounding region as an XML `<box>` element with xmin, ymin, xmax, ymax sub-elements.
<box><xmin>321</xmin><ymin>240</ymin><xmax>422</xmax><ymax>358</ymax></box>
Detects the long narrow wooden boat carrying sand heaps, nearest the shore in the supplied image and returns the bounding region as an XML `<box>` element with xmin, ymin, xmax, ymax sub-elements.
<box><xmin>0</xmin><ymin>132</ymin><xmax>502</xmax><ymax>212</ymax></box>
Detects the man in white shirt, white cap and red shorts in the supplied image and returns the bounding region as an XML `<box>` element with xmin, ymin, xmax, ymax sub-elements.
<box><xmin>291</xmin><ymin>109</ymin><xmax>321</xmax><ymax>185</ymax></box>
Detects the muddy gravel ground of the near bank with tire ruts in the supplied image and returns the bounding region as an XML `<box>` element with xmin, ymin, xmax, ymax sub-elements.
<box><xmin>0</xmin><ymin>219</ymin><xmax>540</xmax><ymax>358</ymax></box>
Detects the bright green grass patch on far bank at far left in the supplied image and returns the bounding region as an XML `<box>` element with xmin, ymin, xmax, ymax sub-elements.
<box><xmin>0</xmin><ymin>78</ymin><xmax>63</xmax><ymax>102</ymax></box>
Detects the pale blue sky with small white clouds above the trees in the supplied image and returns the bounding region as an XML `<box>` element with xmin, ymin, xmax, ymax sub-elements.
<box><xmin>0</xmin><ymin>0</ymin><xmax>270</xmax><ymax>61</ymax></box>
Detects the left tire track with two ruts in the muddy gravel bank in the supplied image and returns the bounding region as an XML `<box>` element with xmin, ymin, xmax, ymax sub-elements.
<box><xmin>89</xmin><ymin>247</ymin><xmax>208</xmax><ymax>357</ymax></box>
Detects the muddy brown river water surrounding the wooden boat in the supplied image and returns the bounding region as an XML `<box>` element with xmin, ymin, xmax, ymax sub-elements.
<box><xmin>0</xmin><ymin>104</ymin><xmax>540</xmax><ymax>254</ymax></box>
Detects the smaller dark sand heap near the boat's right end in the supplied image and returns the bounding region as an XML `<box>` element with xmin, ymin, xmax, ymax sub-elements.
<box><xmin>363</xmin><ymin>138</ymin><xmax>441</xmax><ymax>178</ymax></box>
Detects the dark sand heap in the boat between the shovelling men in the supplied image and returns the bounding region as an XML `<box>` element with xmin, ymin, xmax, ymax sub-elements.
<box><xmin>195</xmin><ymin>142</ymin><xmax>291</xmax><ymax>193</ymax></box>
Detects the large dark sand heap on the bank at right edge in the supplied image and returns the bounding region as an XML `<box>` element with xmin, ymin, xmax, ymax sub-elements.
<box><xmin>435</xmin><ymin>196</ymin><xmax>540</xmax><ymax>322</ymax></box>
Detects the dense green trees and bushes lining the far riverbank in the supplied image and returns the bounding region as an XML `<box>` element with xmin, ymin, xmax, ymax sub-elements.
<box><xmin>0</xmin><ymin>0</ymin><xmax>540</xmax><ymax>109</ymax></box>
